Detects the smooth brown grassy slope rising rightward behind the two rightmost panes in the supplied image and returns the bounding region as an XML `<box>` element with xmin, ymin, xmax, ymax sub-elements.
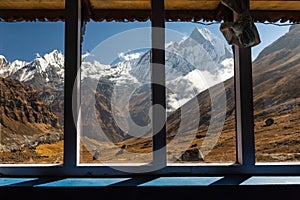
<box><xmin>99</xmin><ymin>25</ymin><xmax>300</xmax><ymax>162</ymax></box>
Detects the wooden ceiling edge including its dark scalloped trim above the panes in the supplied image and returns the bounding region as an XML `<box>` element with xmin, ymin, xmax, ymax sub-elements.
<box><xmin>0</xmin><ymin>0</ymin><xmax>300</xmax><ymax>22</ymax></box>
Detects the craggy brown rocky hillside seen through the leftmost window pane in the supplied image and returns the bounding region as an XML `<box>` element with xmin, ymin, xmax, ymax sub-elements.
<box><xmin>0</xmin><ymin>78</ymin><xmax>63</xmax><ymax>162</ymax></box>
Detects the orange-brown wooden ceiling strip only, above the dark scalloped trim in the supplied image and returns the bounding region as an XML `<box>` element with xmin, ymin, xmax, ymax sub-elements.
<box><xmin>0</xmin><ymin>0</ymin><xmax>300</xmax><ymax>11</ymax></box>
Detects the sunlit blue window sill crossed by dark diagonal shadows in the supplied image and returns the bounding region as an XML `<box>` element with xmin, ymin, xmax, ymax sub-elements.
<box><xmin>0</xmin><ymin>175</ymin><xmax>300</xmax><ymax>188</ymax></box>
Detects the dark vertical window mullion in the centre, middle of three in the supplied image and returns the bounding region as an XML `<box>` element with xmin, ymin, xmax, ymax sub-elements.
<box><xmin>151</xmin><ymin>0</ymin><xmax>167</xmax><ymax>167</ymax></box>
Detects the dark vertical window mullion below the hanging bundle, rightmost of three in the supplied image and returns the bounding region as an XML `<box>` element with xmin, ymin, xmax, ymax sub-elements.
<box><xmin>234</xmin><ymin>0</ymin><xmax>255</xmax><ymax>166</ymax></box>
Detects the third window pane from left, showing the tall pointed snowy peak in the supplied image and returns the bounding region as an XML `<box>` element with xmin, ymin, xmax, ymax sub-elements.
<box><xmin>166</xmin><ymin>22</ymin><xmax>236</xmax><ymax>164</ymax></box>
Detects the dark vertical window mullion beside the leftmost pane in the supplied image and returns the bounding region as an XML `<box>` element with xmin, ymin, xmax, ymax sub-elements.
<box><xmin>64</xmin><ymin>0</ymin><xmax>81</xmax><ymax>167</ymax></box>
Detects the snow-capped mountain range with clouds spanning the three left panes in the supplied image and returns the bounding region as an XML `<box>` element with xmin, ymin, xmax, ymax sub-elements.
<box><xmin>0</xmin><ymin>28</ymin><xmax>233</xmax><ymax>112</ymax></box>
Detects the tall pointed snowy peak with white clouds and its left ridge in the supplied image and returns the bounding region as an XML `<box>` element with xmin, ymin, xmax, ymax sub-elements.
<box><xmin>99</xmin><ymin>28</ymin><xmax>233</xmax><ymax>112</ymax></box>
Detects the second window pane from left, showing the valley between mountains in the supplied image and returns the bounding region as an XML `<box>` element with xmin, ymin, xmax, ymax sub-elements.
<box><xmin>80</xmin><ymin>22</ymin><xmax>152</xmax><ymax>164</ymax></box>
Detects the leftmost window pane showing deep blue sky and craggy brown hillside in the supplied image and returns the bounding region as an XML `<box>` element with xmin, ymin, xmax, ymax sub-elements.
<box><xmin>0</xmin><ymin>22</ymin><xmax>64</xmax><ymax>164</ymax></box>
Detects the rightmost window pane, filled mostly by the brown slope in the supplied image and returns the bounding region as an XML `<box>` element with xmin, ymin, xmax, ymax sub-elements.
<box><xmin>253</xmin><ymin>24</ymin><xmax>300</xmax><ymax>162</ymax></box>
